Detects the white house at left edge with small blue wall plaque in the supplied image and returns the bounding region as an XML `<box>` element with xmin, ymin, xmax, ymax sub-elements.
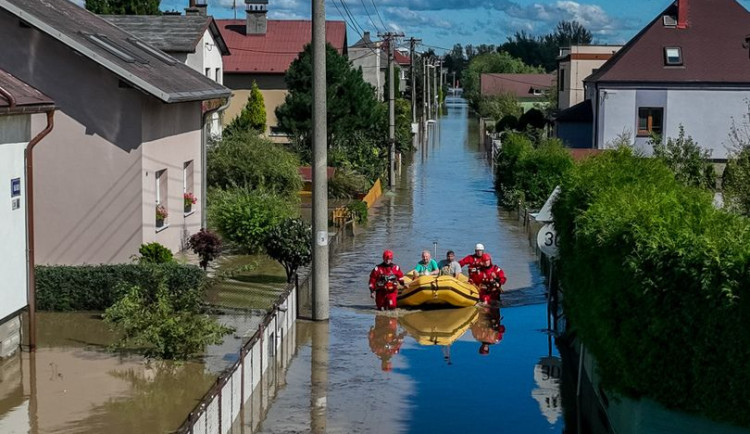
<box><xmin>0</xmin><ymin>69</ymin><xmax>55</xmax><ymax>359</ymax></box>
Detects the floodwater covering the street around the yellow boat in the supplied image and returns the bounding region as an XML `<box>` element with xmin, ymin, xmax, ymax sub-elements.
<box><xmin>250</xmin><ymin>100</ymin><xmax>564</xmax><ymax>433</ymax></box>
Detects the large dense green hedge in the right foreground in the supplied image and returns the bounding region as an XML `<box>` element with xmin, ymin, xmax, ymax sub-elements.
<box><xmin>553</xmin><ymin>149</ymin><xmax>750</xmax><ymax>425</ymax></box>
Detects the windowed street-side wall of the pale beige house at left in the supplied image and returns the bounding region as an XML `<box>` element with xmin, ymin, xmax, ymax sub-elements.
<box><xmin>140</xmin><ymin>100</ymin><xmax>203</xmax><ymax>251</ymax></box>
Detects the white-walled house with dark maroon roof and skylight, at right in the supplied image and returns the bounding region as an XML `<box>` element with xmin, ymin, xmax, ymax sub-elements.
<box><xmin>588</xmin><ymin>0</ymin><xmax>750</xmax><ymax>161</ymax></box>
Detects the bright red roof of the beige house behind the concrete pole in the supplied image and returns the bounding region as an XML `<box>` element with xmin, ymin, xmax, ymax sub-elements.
<box><xmin>216</xmin><ymin>20</ymin><xmax>346</xmax><ymax>74</ymax></box>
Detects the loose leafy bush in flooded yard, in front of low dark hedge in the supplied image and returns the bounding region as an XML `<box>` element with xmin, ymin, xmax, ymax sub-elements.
<box><xmin>104</xmin><ymin>281</ymin><xmax>232</xmax><ymax>360</ymax></box>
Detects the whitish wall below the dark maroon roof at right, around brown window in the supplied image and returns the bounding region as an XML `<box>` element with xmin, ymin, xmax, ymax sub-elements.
<box><xmin>596</xmin><ymin>87</ymin><xmax>750</xmax><ymax>160</ymax></box>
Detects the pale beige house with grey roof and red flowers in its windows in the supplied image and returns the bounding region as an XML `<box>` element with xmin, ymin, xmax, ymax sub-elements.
<box><xmin>0</xmin><ymin>0</ymin><xmax>230</xmax><ymax>264</ymax></box>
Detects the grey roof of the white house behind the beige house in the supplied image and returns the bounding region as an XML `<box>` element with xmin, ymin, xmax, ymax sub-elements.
<box><xmin>101</xmin><ymin>15</ymin><xmax>229</xmax><ymax>56</ymax></box>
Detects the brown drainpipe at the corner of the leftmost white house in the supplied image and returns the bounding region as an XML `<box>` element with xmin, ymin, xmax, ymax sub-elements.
<box><xmin>26</xmin><ymin>111</ymin><xmax>55</xmax><ymax>350</ymax></box>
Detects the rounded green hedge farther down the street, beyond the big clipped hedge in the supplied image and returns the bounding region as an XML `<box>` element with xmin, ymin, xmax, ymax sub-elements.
<box><xmin>495</xmin><ymin>133</ymin><xmax>573</xmax><ymax>208</ymax></box>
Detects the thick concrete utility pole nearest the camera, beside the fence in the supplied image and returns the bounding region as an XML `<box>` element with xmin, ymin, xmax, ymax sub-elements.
<box><xmin>312</xmin><ymin>0</ymin><xmax>329</xmax><ymax>321</ymax></box>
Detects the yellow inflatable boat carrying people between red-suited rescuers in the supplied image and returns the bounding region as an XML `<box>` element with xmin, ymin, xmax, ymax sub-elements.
<box><xmin>398</xmin><ymin>275</ymin><xmax>479</xmax><ymax>307</ymax></box>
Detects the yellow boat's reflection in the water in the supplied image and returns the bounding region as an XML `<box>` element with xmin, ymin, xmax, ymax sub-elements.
<box><xmin>398</xmin><ymin>307</ymin><xmax>479</xmax><ymax>345</ymax></box>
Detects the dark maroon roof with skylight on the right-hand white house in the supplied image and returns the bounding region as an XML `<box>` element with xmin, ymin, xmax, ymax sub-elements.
<box><xmin>586</xmin><ymin>0</ymin><xmax>750</xmax><ymax>84</ymax></box>
